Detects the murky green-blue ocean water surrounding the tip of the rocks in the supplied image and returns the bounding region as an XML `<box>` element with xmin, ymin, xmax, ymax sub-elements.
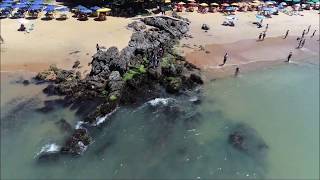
<box><xmin>1</xmin><ymin>60</ymin><xmax>319</xmax><ymax>179</ymax></box>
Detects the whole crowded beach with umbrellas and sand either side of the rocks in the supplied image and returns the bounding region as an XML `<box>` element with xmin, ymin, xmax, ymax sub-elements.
<box><xmin>0</xmin><ymin>0</ymin><xmax>319</xmax><ymax>77</ymax></box>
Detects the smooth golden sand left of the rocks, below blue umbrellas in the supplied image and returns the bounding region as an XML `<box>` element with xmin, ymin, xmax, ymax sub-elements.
<box><xmin>1</xmin><ymin>15</ymin><xmax>132</xmax><ymax>72</ymax></box>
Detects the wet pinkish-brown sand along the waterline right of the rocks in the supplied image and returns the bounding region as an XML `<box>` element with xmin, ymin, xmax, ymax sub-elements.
<box><xmin>186</xmin><ymin>37</ymin><xmax>319</xmax><ymax>80</ymax></box>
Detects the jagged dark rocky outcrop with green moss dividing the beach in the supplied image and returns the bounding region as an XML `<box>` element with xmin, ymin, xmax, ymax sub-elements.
<box><xmin>36</xmin><ymin>17</ymin><xmax>203</xmax><ymax>154</ymax></box>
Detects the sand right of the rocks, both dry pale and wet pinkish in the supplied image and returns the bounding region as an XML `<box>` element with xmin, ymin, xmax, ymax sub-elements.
<box><xmin>180</xmin><ymin>11</ymin><xmax>319</xmax><ymax>80</ymax></box>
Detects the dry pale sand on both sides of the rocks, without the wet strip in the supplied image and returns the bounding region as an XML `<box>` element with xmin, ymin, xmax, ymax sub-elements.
<box><xmin>1</xmin><ymin>11</ymin><xmax>319</xmax><ymax>72</ymax></box>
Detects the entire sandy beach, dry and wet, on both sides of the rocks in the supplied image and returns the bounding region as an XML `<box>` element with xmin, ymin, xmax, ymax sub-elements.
<box><xmin>1</xmin><ymin>11</ymin><xmax>319</xmax><ymax>77</ymax></box>
